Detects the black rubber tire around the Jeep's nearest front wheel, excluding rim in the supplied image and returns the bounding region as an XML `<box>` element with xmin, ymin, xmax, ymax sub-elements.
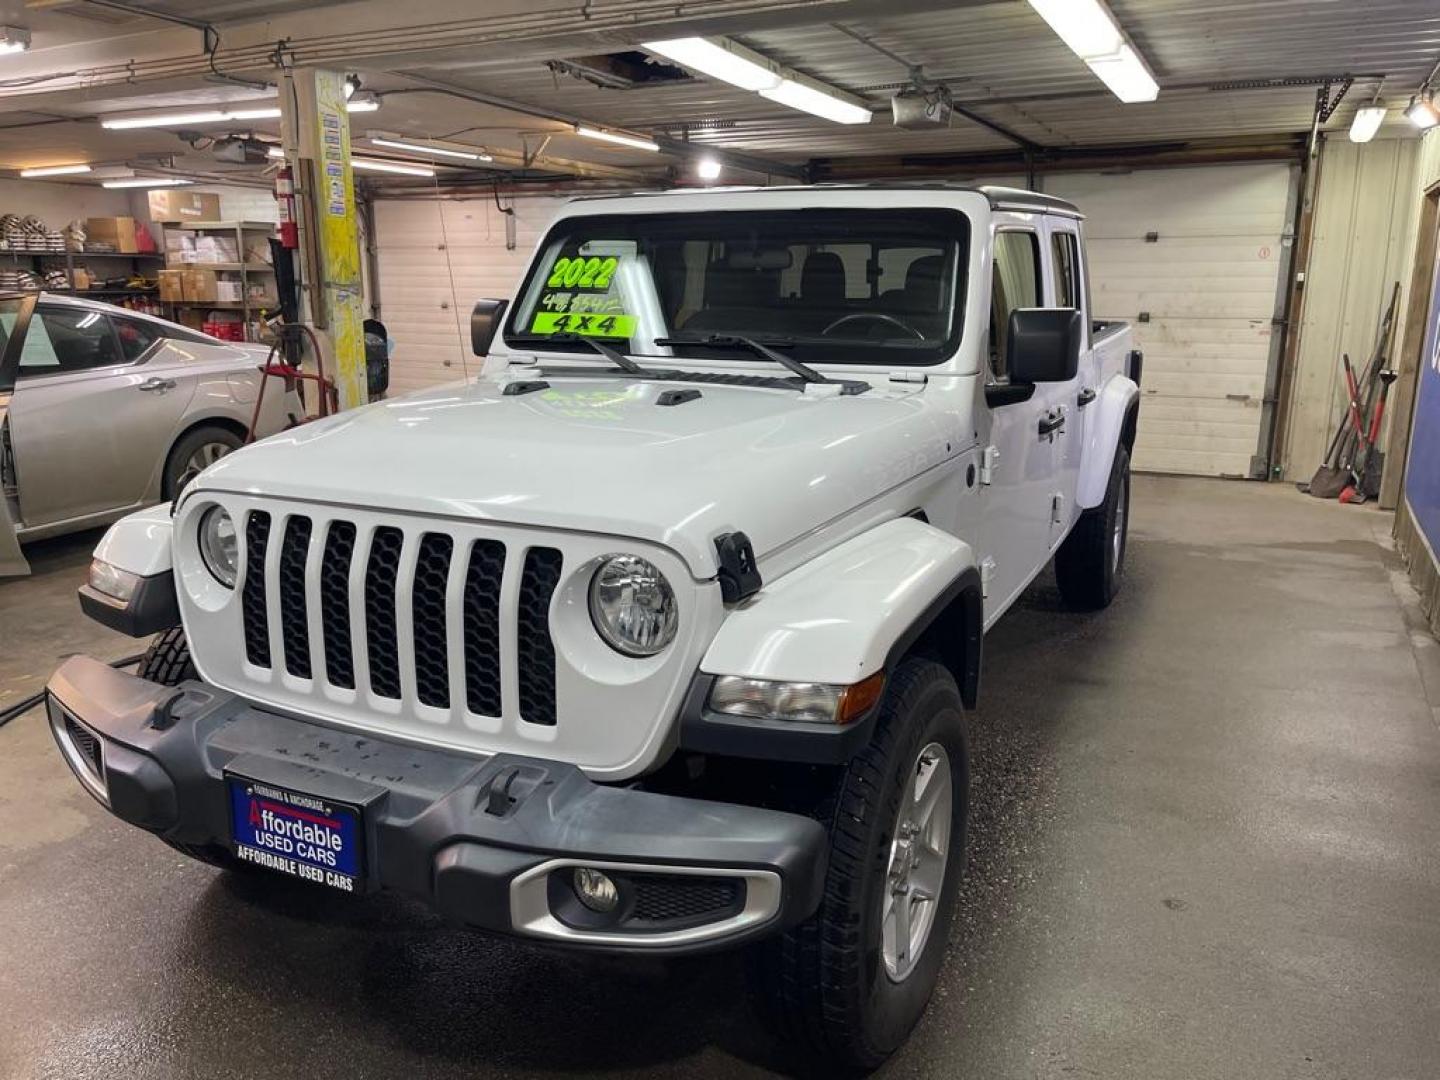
<box><xmin>753</xmin><ymin>660</ymin><xmax>969</xmax><ymax>1076</ymax></box>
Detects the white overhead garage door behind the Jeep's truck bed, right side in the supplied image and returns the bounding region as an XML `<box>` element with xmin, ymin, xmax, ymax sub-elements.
<box><xmin>1045</xmin><ymin>164</ymin><xmax>1293</xmax><ymax>477</ymax></box>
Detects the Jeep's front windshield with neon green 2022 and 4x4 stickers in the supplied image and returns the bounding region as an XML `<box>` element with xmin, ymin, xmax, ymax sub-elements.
<box><xmin>505</xmin><ymin>209</ymin><xmax>969</xmax><ymax>366</ymax></box>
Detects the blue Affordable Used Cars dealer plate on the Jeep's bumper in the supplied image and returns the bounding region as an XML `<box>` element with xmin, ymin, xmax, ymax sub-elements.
<box><xmin>226</xmin><ymin>776</ymin><xmax>363</xmax><ymax>893</ymax></box>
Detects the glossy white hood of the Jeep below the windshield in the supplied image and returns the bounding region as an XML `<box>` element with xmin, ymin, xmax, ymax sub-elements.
<box><xmin>194</xmin><ymin>374</ymin><xmax>958</xmax><ymax>577</ymax></box>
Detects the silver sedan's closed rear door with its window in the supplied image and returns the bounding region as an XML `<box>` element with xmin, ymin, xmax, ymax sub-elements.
<box><xmin>10</xmin><ymin>302</ymin><xmax>194</xmax><ymax>528</ymax></box>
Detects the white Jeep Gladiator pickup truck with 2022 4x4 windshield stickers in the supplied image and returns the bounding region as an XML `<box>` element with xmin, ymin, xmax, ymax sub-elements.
<box><xmin>48</xmin><ymin>184</ymin><xmax>1140</xmax><ymax>1068</ymax></box>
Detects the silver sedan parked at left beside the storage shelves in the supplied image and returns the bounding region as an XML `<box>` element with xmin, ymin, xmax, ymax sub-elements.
<box><xmin>0</xmin><ymin>292</ymin><xmax>302</xmax><ymax>575</ymax></box>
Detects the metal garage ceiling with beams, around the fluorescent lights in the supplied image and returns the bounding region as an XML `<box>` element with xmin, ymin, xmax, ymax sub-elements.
<box><xmin>0</xmin><ymin>0</ymin><xmax>1440</xmax><ymax>179</ymax></box>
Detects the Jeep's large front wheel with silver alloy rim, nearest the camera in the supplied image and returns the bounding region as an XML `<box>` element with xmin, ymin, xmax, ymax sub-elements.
<box><xmin>756</xmin><ymin>660</ymin><xmax>969</xmax><ymax>1073</ymax></box>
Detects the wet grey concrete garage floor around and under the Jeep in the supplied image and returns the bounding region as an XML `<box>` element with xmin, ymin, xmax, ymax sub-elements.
<box><xmin>0</xmin><ymin>477</ymin><xmax>1440</xmax><ymax>1080</ymax></box>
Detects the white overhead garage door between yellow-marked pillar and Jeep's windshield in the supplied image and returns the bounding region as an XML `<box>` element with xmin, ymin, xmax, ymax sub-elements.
<box><xmin>374</xmin><ymin>199</ymin><xmax>564</xmax><ymax>393</ymax></box>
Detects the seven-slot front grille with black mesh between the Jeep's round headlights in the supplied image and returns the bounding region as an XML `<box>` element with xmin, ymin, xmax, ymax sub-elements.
<box><xmin>240</xmin><ymin>510</ymin><xmax>563</xmax><ymax>724</ymax></box>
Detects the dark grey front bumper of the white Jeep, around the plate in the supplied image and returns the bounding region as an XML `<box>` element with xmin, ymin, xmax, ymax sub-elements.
<box><xmin>48</xmin><ymin>657</ymin><xmax>827</xmax><ymax>955</ymax></box>
